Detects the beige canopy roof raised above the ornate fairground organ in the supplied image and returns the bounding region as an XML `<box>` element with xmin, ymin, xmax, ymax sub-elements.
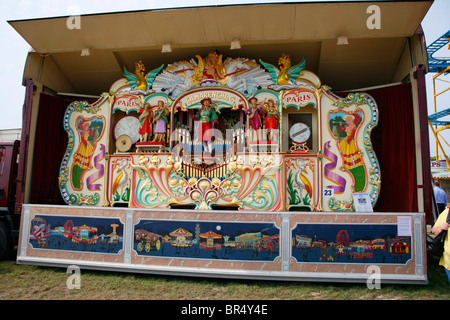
<box><xmin>9</xmin><ymin>0</ymin><xmax>433</xmax><ymax>95</ymax></box>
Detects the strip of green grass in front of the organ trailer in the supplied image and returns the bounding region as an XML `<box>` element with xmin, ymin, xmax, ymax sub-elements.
<box><xmin>0</xmin><ymin>252</ymin><xmax>450</xmax><ymax>300</ymax></box>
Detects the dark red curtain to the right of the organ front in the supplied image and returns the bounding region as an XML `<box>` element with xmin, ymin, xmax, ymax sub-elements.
<box><xmin>341</xmin><ymin>84</ymin><xmax>418</xmax><ymax>212</ymax></box>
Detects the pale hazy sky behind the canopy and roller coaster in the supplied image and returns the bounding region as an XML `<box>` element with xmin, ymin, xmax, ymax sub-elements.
<box><xmin>0</xmin><ymin>0</ymin><xmax>450</xmax><ymax>155</ymax></box>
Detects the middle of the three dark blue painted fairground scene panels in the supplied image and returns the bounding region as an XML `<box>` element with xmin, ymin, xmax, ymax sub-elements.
<box><xmin>133</xmin><ymin>220</ymin><xmax>280</xmax><ymax>262</ymax></box>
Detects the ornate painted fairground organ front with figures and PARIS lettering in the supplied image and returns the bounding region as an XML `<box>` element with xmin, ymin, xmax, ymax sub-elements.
<box><xmin>59</xmin><ymin>52</ymin><xmax>380</xmax><ymax>211</ymax></box>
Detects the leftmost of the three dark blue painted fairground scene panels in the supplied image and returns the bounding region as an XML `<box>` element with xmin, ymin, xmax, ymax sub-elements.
<box><xmin>29</xmin><ymin>215</ymin><xmax>123</xmax><ymax>254</ymax></box>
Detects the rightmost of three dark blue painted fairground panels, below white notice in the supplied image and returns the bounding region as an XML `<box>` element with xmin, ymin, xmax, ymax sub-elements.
<box><xmin>292</xmin><ymin>224</ymin><xmax>412</xmax><ymax>264</ymax></box>
